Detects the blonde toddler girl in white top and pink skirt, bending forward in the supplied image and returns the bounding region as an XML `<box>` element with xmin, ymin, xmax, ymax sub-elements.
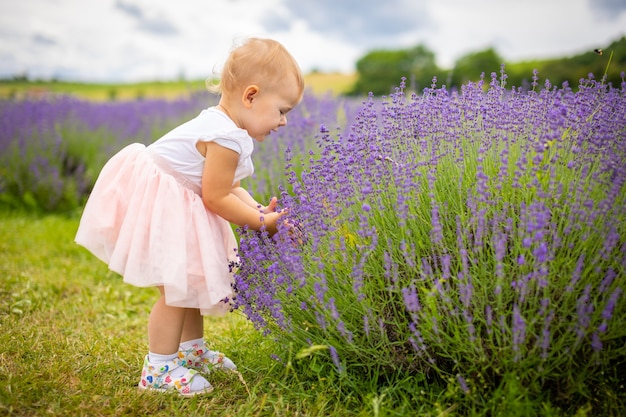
<box><xmin>76</xmin><ymin>38</ymin><xmax>304</xmax><ymax>396</ymax></box>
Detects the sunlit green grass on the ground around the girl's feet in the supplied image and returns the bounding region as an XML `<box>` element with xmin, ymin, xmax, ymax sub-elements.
<box><xmin>0</xmin><ymin>213</ymin><xmax>371</xmax><ymax>416</ymax></box>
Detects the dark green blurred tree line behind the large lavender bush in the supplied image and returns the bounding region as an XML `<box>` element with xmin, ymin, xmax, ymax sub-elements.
<box><xmin>349</xmin><ymin>37</ymin><xmax>626</xmax><ymax>95</ymax></box>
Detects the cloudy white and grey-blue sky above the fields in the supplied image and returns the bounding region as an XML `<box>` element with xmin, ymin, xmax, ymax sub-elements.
<box><xmin>0</xmin><ymin>0</ymin><xmax>626</xmax><ymax>82</ymax></box>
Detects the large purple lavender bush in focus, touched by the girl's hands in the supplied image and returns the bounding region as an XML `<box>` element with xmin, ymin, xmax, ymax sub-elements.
<box><xmin>235</xmin><ymin>71</ymin><xmax>626</xmax><ymax>415</ymax></box>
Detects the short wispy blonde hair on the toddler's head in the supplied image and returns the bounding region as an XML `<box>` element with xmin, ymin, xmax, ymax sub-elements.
<box><xmin>206</xmin><ymin>38</ymin><xmax>304</xmax><ymax>95</ymax></box>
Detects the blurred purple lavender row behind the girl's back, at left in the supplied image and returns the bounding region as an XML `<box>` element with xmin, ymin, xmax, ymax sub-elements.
<box><xmin>0</xmin><ymin>95</ymin><xmax>214</xmax><ymax>211</ymax></box>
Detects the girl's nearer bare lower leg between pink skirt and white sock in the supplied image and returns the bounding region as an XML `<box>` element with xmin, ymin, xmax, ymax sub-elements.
<box><xmin>148</xmin><ymin>287</ymin><xmax>186</xmax><ymax>355</ymax></box>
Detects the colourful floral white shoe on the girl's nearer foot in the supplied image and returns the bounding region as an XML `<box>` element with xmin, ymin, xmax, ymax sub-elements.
<box><xmin>139</xmin><ymin>355</ymin><xmax>213</xmax><ymax>397</ymax></box>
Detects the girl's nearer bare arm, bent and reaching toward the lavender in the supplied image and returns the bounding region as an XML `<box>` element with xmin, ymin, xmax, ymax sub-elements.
<box><xmin>202</xmin><ymin>142</ymin><xmax>283</xmax><ymax>234</ymax></box>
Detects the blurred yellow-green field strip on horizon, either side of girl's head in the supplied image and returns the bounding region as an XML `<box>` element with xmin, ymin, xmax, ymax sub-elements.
<box><xmin>0</xmin><ymin>72</ymin><xmax>357</xmax><ymax>101</ymax></box>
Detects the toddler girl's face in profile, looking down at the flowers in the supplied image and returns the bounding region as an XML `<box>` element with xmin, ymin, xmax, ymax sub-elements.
<box><xmin>241</xmin><ymin>76</ymin><xmax>302</xmax><ymax>142</ymax></box>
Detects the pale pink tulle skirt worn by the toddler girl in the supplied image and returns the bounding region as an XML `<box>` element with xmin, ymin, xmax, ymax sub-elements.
<box><xmin>76</xmin><ymin>144</ymin><xmax>237</xmax><ymax>314</ymax></box>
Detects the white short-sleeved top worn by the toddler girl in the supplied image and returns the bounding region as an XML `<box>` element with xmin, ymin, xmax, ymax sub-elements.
<box><xmin>149</xmin><ymin>107</ymin><xmax>254</xmax><ymax>187</ymax></box>
